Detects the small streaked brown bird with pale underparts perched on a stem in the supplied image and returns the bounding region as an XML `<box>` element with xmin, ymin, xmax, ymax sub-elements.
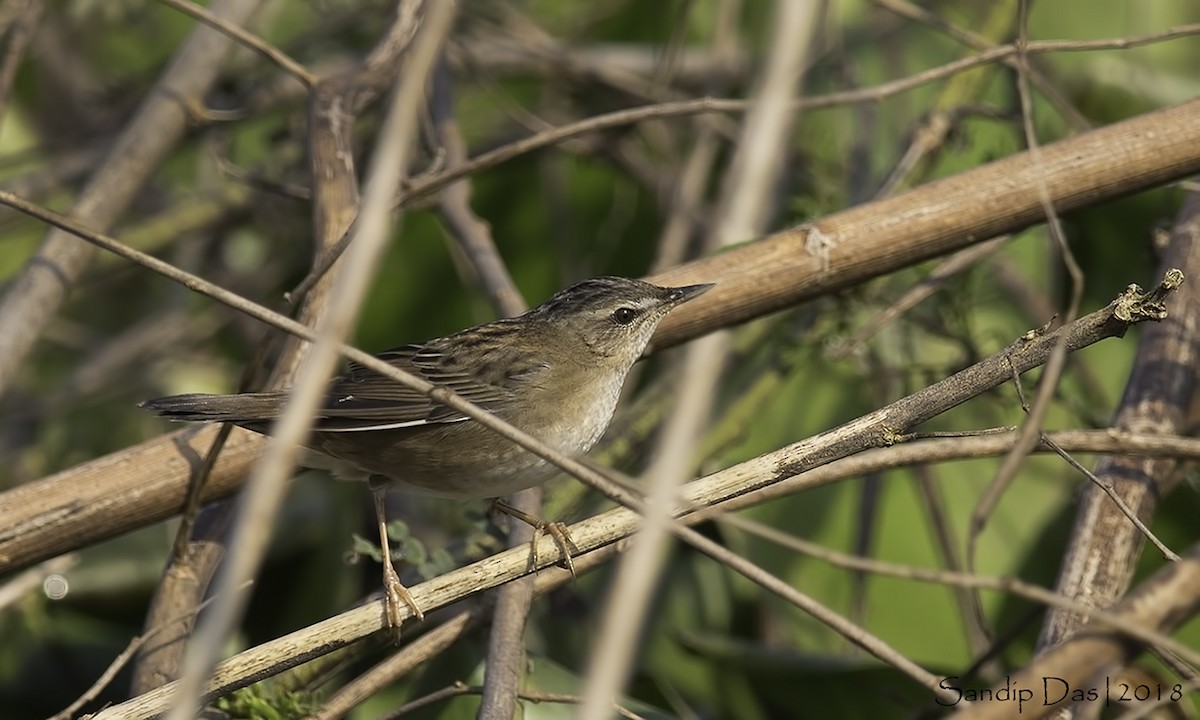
<box><xmin>142</xmin><ymin>277</ymin><xmax>713</xmax><ymax>628</ymax></box>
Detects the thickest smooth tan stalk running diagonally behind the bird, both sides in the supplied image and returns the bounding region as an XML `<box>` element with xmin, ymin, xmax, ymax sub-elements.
<box><xmin>0</xmin><ymin>101</ymin><xmax>1200</xmax><ymax>572</ymax></box>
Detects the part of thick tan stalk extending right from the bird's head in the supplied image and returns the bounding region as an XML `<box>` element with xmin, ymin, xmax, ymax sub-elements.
<box><xmin>654</xmin><ymin>94</ymin><xmax>1200</xmax><ymax>347</ymax></box>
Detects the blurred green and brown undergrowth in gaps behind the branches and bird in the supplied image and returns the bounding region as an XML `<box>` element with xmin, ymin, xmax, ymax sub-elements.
<box><xmin>0</xmin><ymin>0</ymin><xmax>1200</xmax><ymax>719</ymax></box>
